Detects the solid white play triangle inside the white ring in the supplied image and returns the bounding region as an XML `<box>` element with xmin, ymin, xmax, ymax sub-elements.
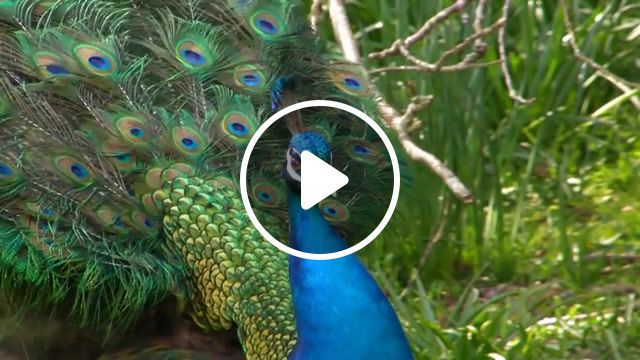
<box><xmin>300</xmin><ymin>151</ymin><xmax>349</xmax><ymax>210</ymax></box>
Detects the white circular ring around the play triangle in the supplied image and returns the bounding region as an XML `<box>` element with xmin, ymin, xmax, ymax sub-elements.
<box><xmin>240</xmin><ymin>100</ymin><xmax>400</xmax><ymax>260</ymax></box>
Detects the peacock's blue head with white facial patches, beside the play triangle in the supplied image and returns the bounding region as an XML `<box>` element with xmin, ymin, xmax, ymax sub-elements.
<box><xmin>284</xmin><ymin>131</ymin><xmax>331</xmax><ymax>185</ymax></box>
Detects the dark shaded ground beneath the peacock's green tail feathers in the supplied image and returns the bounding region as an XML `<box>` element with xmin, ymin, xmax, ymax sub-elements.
<box><xmin>0</xmin><ymin>303</ymin><xmax>244</xmax><ymax>360</ymax></box>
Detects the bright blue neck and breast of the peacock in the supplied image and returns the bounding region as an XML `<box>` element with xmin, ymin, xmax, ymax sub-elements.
<box><xmin>289</xmin><ymin>191</ymin><xmax>412</xmax><ymax>360</ymax></box>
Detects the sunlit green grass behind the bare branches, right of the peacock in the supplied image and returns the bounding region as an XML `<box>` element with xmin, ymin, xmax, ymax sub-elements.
<box><xmin>308</xmin><ymin>0</ymin><xmax>640</xmax><ymax>359</ymax></box>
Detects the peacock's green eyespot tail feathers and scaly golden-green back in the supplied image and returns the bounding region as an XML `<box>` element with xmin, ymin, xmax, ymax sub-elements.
<box><xmin>0</xmin><ymin>0</ymin><xmax>410</xmax><ymax>359</ymax></box>
